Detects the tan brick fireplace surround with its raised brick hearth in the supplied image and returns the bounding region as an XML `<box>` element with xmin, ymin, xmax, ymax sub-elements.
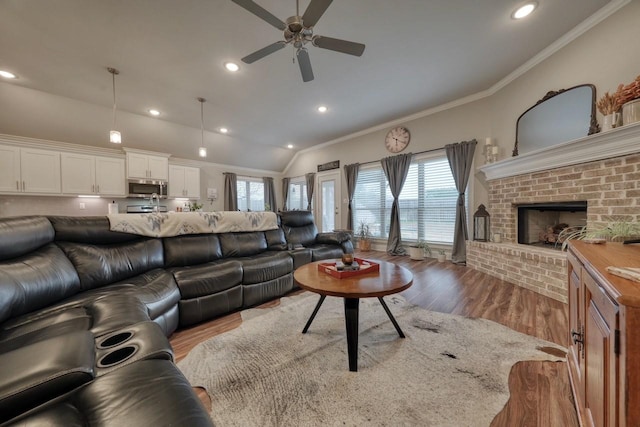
<box><xmin>467</xmin><ymin>154</ymin><xmax>640</xmax><ymax>302</ymax></box>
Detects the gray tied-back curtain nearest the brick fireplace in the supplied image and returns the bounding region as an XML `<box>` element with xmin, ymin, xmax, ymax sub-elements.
<box><xmin>444</xmin><ymin>139</ymin><xmax>477</xmax><ymax>264</ymax></box>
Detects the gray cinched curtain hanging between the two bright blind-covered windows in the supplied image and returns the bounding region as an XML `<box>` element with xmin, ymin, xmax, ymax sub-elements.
<box><xmin>381</xmin><ymin>153</ymin><xmax>413</xmax><ymax>255</ymax></box>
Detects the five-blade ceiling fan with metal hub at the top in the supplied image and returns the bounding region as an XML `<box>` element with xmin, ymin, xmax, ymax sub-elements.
<box><xmin>231</xmin><ymin>0</ymin><xmax>365</xmax><ymax>82</ymax></box>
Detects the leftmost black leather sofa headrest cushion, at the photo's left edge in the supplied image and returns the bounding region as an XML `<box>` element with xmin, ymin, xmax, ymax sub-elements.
<box><xmin>0</xmin><ymin>217</ymin><xmax>54</xmax><ymax>261</ymax></box>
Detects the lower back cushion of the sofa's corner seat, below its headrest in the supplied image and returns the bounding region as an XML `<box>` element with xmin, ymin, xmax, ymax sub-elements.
<box><xmin>58</xmin><ymin>239</ymin><xmax>164</xmax><ymax>290</ymax></box>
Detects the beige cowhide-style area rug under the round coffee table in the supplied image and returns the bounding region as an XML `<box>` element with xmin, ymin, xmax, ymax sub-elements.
<box><xmin>178</xmin><ymin>293</ymin><xmax>566</xmax><ymax>427</ymax></box>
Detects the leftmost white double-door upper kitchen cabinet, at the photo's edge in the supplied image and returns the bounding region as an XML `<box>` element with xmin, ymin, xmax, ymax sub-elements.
<box><xmin>0</xmin><ymin>146</ymin><xmax>61</xmax><ymax>194</ymax></box>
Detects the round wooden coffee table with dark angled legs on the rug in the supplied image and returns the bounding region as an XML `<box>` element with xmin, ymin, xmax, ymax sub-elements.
<box><xmin>293</xmin><ymin>260</ymin><xmax>413</xmax><ymax>371</ymax></box>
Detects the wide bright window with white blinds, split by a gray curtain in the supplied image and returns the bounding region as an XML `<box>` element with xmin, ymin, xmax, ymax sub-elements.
<box><xmin>353</xmin><ymin>156</ymin><xmax>458</xmax><ymax>243</ymax></box>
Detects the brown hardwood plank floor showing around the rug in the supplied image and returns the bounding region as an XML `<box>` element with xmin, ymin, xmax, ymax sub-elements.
<box><xmin>171</xmin><ymin>251</ymin><xmax>578</xmax><ymax>427</ymax></box>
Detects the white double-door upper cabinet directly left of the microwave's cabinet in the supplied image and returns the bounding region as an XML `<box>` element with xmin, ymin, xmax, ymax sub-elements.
<box><xmin>61</xmin><ymin>153</ymin><xmax>125</xmax><ymax>196</ymax></box>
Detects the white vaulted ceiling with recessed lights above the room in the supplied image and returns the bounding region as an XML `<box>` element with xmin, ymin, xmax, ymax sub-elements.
<box><xmin>0</xmin><ymin>0</ymin><xmax>609</xmax><ymax>171</ymax></box>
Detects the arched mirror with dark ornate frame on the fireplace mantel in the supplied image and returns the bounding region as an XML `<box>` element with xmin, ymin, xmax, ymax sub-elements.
<box><xmin>513</xmin><ymin>84</ymin><xmax>600</xmax><ymax>156</ymax></box>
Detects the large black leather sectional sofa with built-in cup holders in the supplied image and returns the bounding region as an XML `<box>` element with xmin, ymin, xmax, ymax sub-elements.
<box><xmin>0</xmin><ymin>211</ymin><xmax>353</xmax><ymax>426</ymax></box>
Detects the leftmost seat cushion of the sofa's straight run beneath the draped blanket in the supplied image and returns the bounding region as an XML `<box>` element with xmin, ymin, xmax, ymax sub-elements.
<box><xmin>171</xmin><ymin>260</ymin><xmax>242</xmax><ymax>299</ymax></box>
